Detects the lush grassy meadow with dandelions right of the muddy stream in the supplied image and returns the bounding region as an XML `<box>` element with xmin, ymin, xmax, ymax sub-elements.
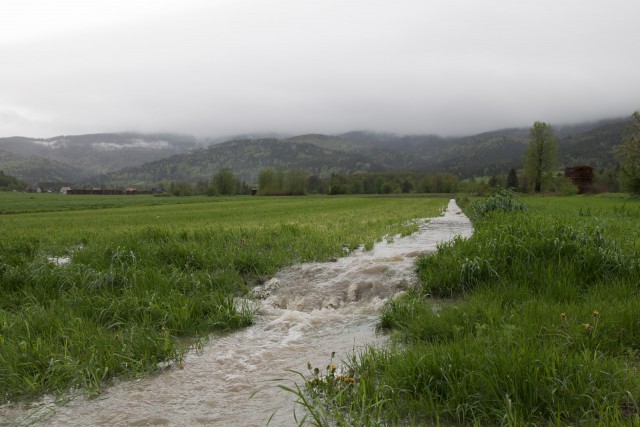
<box><xmin>296</xmin><ymin>192</ymin><xmax>640</xmax><ymax>426</ymax></box>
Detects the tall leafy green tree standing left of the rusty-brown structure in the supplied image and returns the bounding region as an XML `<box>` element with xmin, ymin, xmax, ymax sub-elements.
<box><xmin>524</xmin><ymin>122</ymin><xmax>558</xmax><ymax>193</ymax></box>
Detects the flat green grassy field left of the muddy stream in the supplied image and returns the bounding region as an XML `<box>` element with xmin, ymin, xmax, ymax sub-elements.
<box><xmin>0</xmin><ymin>193</ymin><xmax>447</xmax><ymax>402</ymax></box>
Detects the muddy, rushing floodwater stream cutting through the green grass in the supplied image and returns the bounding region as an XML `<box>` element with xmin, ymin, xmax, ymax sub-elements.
<box><xmin>0</xmin><ymin>200</ymin><xmax>473</xmax><ymax>426</ymax></box>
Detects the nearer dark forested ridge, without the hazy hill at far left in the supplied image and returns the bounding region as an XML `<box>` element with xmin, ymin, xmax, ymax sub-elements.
<box><xmin>96</xmin><ymin>120</ymin><xmax>628</xmax><ymax>185</ymax></box>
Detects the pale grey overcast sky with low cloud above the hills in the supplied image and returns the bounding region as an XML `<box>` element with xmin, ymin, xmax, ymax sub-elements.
<box><xmin>0</xmin><ymin>0</ymin><xmax>640</xmax><ymax>137</ymax></box>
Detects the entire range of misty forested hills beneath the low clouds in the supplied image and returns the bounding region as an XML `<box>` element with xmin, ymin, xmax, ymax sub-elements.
<box><xmin>0</xmin><ymin>119</ymin><xmax>629</xmax><ymax>186</ymax></box>
